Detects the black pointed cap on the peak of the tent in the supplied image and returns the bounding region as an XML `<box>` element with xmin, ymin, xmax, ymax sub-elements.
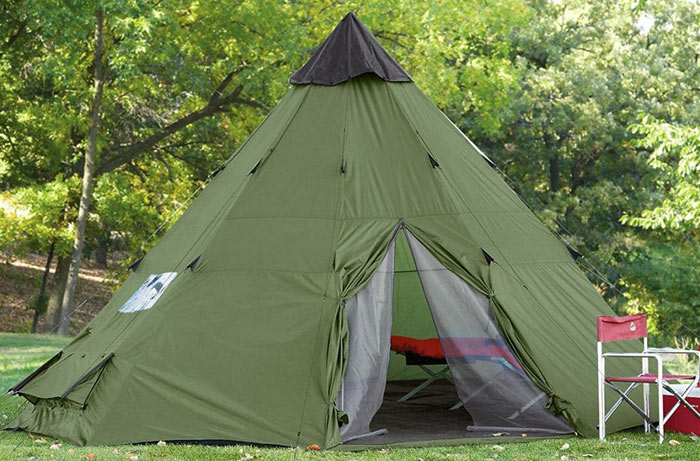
<box><xmin>289</xmin><ymin>13</ymin><xmax>412</xmax><ymax>86</ymax></box>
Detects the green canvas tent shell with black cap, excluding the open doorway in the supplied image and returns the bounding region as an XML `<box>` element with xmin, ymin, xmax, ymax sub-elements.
<box><xmin>5</xmin><ymin>15</ymin><xmax>637</xmax><ymax>447</ymax></box>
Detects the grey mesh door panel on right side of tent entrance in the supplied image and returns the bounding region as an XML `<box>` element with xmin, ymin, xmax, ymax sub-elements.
<box><xmin>404</xmin><ymin>229</ymin><xmax>572</xmax><ymax>433</ymax></box>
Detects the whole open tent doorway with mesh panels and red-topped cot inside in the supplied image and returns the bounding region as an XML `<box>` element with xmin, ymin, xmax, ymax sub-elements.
<box><xmin>336</xmin><ymin>227</ymin><xmax>573</xmax><ymax>445</ymax></box>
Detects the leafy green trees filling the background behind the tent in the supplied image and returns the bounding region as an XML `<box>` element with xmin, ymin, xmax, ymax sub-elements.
<box><xmin>0</xmin><ymin>0</ymin><xmax>700</xmax><ymax>340</ymax></box>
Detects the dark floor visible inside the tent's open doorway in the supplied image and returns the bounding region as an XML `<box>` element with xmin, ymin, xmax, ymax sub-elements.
<box><xmin>345</xmin><ymin>380</ymin><xmax>476</xmax><ymax>445</ymax></box>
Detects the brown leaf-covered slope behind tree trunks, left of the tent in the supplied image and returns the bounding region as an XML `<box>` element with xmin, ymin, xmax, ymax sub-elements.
<box><xmin>0</xmin><ymin>253</ymin><xmax>117</xmax><ymax>334</ymax></box>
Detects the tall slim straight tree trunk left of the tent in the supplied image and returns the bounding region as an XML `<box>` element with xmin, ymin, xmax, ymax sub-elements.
<box><xmin>58</xmin><ymin>8</ymin><xmax>104</xmax><ymax>336</ymax></box>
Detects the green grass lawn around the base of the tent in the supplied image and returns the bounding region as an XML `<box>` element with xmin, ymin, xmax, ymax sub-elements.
<box><xmin>0</xmin><ymin>333</ymin><xmax>700</xmax><ymax>461</ymax></box>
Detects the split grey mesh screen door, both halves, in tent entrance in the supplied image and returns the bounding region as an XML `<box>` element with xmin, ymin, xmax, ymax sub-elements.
<box><xmin>336</xmin><ymin>229</ymin><xmax>572</xmax><ymax>442</ymax></box>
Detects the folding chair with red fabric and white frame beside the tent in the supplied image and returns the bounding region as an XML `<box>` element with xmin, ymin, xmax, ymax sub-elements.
<box><xmin>598</xmin><ymin>314</ymin><xmax>700</xmax><ymax>443</ymax></box>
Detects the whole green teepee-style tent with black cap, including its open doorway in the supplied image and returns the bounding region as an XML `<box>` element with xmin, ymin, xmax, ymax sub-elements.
<box><xmin>7</xmin><ymin>14</ymin><xmax>638</xmax><ymax>448</ymax></box>
